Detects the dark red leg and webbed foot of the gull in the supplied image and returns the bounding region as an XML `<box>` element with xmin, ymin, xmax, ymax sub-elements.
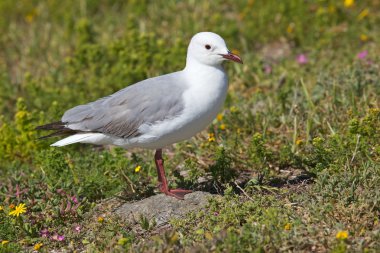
<box><xmin>154</xmin><ymin>149</ymin><xmax>192</xmax><ymax>199</ymax></box>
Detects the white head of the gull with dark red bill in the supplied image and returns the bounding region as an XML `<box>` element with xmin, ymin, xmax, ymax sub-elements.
<box><xmin>187</xmin><ymin>32</ymin><xmax>243</xmax><ymax>66</ymax></box>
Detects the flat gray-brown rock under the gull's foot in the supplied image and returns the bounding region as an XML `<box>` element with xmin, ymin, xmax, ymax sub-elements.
<box><xmin>115</xmin><ymin>191</ymin><xmax>215</xmax><ymax>227</ymax></box>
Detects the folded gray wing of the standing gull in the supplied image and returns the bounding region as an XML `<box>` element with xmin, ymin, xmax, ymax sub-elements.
<box><xmin>62</xmin><ymin>72</ymin><xmax>187</xmax><ymax>138</ymax></box>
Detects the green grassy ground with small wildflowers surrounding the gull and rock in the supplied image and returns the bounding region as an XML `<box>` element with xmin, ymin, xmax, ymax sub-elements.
<box><xmin>0</xmin><ymin>0</ymin><xmax>380</xmax><ymax>252</ymax></box>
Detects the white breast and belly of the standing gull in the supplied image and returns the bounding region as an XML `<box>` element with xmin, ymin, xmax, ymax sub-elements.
<box><xmin>127</xmin><ymin>65</ymin><xmax>228</xmax><ymax>149</ymax></box>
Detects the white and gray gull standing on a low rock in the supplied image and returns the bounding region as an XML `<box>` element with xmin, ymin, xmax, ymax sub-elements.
<box><xmin>37</xmin><ymin>32</ymin><xmax>243</xmax><ymax>199</ymax></box>
